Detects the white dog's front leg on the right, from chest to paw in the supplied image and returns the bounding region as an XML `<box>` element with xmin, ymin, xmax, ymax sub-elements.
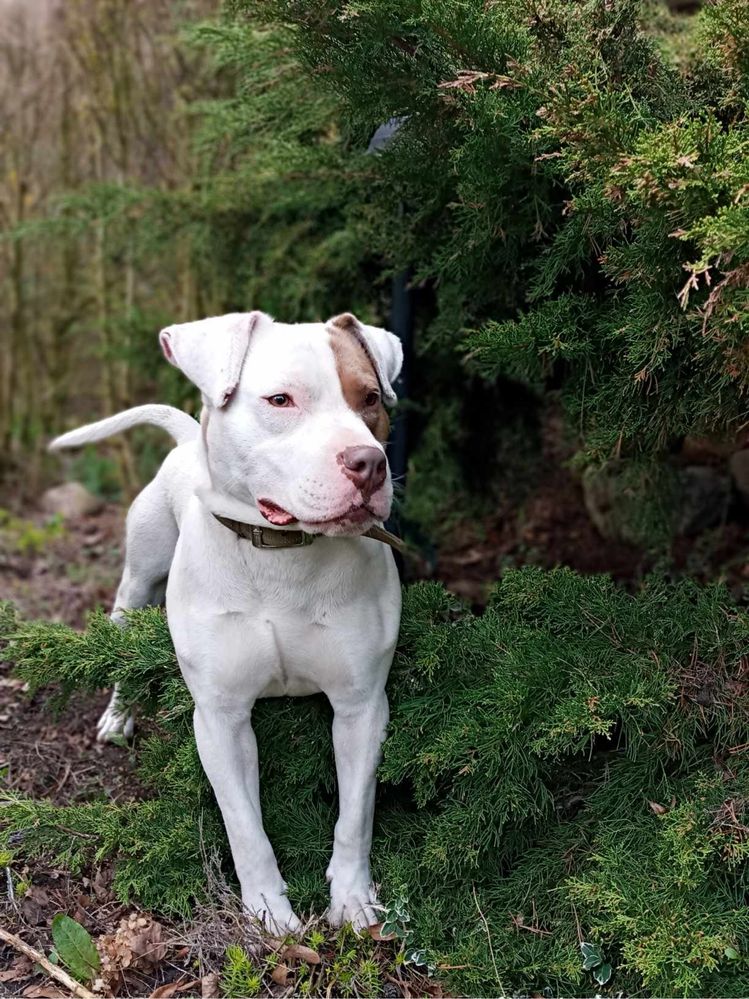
<box><xmin>327</xmin><ymin>690</ymin><xmax>388</xmax><ymax>930</ymax></box>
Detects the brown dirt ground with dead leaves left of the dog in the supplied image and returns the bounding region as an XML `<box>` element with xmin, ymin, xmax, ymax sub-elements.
<box><xmin>0</xmin><ymin>507</ymin><xmax>170</xmax><ymax>997</ymax></box>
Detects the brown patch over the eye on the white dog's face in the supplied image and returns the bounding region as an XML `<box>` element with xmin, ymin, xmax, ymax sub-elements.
<box><xmin>328</xmin><ymin>312</ymin><xmax>390</xmax><ymax>442</ymax></box>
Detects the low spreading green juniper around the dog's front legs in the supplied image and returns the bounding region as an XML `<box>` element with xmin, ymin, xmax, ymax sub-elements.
<box><xmin>0</xmin><ymin>568</ymin><xmax>749</xmax><ymax>996</ymax></box>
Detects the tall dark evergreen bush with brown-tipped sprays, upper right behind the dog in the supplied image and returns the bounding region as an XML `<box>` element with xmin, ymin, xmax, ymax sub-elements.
<box><xmin>224</xmin><ymin>0</ymin><xmax>749</xmax><ymax>521</ymax></box>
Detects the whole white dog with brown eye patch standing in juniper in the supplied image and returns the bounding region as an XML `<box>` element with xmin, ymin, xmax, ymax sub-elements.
<box><xmin>51</xmin><ymin>312</ymin><xmax>402</xmax><ymax>931</ymax></box>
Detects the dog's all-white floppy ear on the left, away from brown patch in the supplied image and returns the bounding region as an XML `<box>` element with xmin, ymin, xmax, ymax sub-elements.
<box><xmin>159</xmin><ymin>312</ymin><xmax>266</xmax><ymax>409</ymax></box>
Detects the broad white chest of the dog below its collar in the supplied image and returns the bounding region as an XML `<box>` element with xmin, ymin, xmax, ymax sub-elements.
<box><xmin>167</xmin><ymin>535</ymin><xmax>400</xmax><ymax>697</ymax></box>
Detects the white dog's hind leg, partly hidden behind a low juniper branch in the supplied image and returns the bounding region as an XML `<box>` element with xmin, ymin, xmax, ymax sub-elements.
<box><xmin>96</xmin><ymin>476</ymin><xmax>179</xmax><ymax>742</ymax></box>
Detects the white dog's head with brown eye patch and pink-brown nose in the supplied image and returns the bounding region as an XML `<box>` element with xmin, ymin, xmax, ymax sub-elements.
<box><xmin>159</xmin><ymin>312</ymin><xmax>403</xmax><ymax>535</ymax></box>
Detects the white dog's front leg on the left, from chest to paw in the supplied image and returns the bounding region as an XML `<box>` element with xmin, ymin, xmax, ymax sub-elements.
<box><xmin>194</xmin><ymin>699</ymin><xmax>301</xmax><ymax>933</ymax></box>
